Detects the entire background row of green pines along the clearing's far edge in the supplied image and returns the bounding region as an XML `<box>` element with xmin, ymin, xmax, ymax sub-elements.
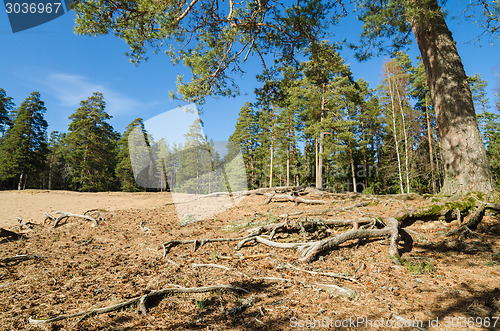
<box><xmin>0</xmin><ymin>52</ymin><xmax>500</xmax><ymax>194</ymax></box>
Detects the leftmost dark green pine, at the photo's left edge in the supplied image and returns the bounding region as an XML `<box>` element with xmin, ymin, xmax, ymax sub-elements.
<box><xmin>0</xmin><ymin>92</ymin><xmax>48</xmax><ymax>190</ymax></box>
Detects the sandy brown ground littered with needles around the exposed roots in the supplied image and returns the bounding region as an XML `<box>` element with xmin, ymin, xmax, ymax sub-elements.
<box><xmin>0</xmin><ymin>190</ymin><xmax>500</xmax><ymax>330</ymax></box>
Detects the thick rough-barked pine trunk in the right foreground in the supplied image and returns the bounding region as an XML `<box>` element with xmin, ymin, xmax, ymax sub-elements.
<box><xmin>410</xmin><ymin>0</ymin><xmax>495</xmax><ymax>194</ymax></box>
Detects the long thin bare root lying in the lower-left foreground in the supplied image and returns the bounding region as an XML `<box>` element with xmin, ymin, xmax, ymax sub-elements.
<box><xmin>28</xmin><ymin>285</ymin><xmax>248</xmax><ymax>325</ymax></box>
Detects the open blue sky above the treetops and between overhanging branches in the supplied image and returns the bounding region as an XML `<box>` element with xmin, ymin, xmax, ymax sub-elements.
<box><xmin>0</xmin><ymin>1</ymin><xmax>500</xmax><ymax>144</ymax></box>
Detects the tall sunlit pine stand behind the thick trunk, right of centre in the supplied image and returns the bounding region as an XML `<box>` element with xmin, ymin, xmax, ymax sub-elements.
<box><xmin>230</xmin><ymin>49</ymin><xmax>500</xmax><ymax>194</ymax></box>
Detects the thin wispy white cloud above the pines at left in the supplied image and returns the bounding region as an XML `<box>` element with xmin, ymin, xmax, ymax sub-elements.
<box><xmin>45</xmin><ymin>73</ymin><xmax>146</xmax><ymax>116</ymax></box>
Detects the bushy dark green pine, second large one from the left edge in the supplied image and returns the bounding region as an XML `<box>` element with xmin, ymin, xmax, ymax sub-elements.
<box><xmin>66</xmin><ymin>92</ymin><xmax>119</xmax><ymax>191</ymax></box>
